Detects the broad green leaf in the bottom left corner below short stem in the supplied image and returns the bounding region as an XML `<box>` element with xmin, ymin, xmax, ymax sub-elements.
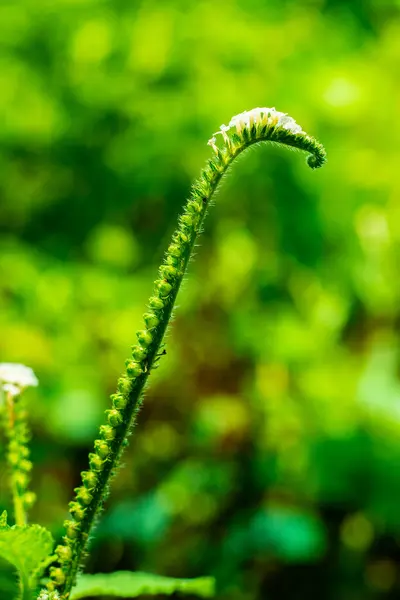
<box><xmin>0</xmin><ymin>513</ymin><xmax>53</xmax><ymax>592</ymax></box>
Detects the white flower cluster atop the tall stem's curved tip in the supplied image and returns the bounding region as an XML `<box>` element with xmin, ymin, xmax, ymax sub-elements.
<box><xmin>208</xmin><ymin>108</ymin><xmax>303</xmax><ymax>151</ymax></box>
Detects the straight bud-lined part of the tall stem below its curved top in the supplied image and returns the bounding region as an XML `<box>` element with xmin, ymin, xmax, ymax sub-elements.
<box><xmin>47</xmin><ymin>173</ymin><xmax>212</xmax><ymax>594</ymax></box>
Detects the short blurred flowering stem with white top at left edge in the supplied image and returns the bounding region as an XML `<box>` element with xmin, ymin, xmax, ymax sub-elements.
<box><xmin>0</xmin><ymin>363</ymin><xmax>38</xmax><ymax>525</ymax></box>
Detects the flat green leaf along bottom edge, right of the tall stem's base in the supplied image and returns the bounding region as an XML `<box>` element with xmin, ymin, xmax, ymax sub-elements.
<box><xmin>71</xmin><ymin>571</ymin><xmax>215</xmax><ymax>600</ymax></box>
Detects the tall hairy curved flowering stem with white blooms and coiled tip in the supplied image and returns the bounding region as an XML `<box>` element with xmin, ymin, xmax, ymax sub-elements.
<box><xmin>48</xmin><ymin>108</ymin><xmax>326</xmax><ymax>600</ymax></box>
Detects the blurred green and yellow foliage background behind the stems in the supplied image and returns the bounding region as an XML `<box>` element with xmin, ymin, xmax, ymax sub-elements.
<box><xmin>0</xmin><ymin>0</ymin><xmax>400</xmax><ymax>600</ymax></box>
